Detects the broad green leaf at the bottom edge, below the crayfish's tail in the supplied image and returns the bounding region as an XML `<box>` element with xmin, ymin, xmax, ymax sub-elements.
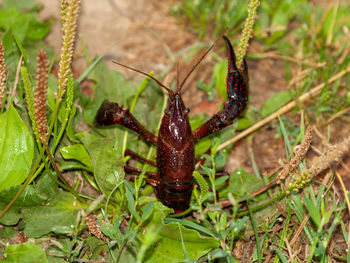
<box><xmin>144</xmin><ymin>223</ymin><xmax>220</xmax><ymax>263</ymax></box>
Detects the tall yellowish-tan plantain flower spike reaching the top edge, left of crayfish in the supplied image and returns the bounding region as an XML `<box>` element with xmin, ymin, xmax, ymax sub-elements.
<box><xmin>57</xmin><ymin>0</ymin><xmax>80</xmax><ymax>100</ymax></box>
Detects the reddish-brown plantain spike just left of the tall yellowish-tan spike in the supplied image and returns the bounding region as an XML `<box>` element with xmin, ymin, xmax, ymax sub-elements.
<box><xmin>34</xmin><ymin>50</ymin><xmax>49</xmax><ymax>143</ymax></box>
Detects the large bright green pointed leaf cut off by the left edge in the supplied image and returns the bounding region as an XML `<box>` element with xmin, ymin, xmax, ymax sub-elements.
<box><xmin>0</xmin><ymin>105</ymin><xmax>34</xmax><ymax>192</ymax></box>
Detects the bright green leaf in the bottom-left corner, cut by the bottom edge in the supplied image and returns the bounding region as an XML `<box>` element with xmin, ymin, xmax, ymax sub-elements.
<box><xmin>4</xmin><ymin>242</ymin><xmax>48</xmax><ymax>263</ymax></box>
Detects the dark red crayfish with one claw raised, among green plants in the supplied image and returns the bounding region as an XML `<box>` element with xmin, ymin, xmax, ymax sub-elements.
<box><xmin>96</xmin><ymin>36</ymin><xmax>248</xmax><ymax>213</ymax></box>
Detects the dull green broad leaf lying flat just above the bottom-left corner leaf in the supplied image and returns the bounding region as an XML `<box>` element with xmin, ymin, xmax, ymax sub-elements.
<box><xmin>22</xmin><ymin>191</ymin><xmax>81</xmax><ymax>237</ymax></box>
